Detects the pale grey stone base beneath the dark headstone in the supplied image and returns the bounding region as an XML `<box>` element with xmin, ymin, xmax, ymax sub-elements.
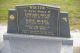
<box><xmin>3</xmin><ymin>33</ymin><xmax>73</xmax><ymax>53</ymax></box>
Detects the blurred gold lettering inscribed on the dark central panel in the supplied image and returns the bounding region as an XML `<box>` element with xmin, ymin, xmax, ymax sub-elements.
<box><xmin>19</xmin><ymin>6</ymin><xmax>53</xmax><ymax>35</ymax></box>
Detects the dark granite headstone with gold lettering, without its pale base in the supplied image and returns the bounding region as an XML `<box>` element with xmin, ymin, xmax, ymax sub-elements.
<box><xmin>8</xmin><ymin>4</ymin><xmax>70</xmax><ymax>37</ymax></box>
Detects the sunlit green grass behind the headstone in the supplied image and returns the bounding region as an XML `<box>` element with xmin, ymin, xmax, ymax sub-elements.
<box><xmin>0</xmin><ymin>0</ymin><xmax>80</xmax><ymax>29</ymax></box>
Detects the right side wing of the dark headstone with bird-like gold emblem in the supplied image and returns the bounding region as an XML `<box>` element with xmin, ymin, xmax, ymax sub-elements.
<box><xmin>60</xmin><ymin>12</ymin><xmax>70</xmax><ymax>37</ymax></box>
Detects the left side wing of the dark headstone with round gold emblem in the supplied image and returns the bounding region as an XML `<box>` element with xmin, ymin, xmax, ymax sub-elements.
<box><xmin>7</xmin><ymin>9</ymin><xmax>17</xmax><ymax>33</ymax></box>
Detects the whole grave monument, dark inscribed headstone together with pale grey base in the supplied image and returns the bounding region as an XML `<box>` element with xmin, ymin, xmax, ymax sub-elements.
<box><xmin>3</xmin><ymin>4</ymin><xmax>73</xmax><ymax>53</ymax></box>
